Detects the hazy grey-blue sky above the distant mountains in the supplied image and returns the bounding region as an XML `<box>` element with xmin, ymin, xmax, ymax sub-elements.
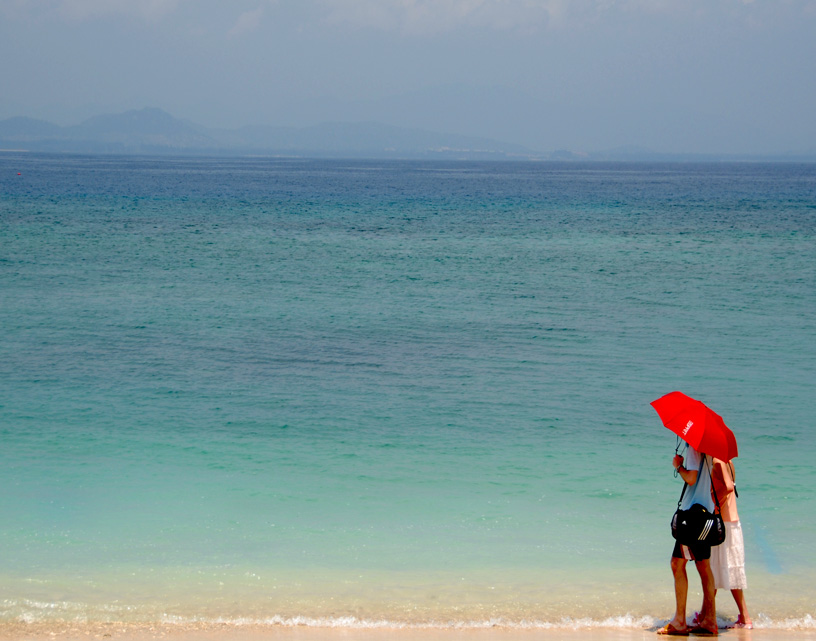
<box><xmin>0</xmin><ymin>0</ymin><xmax>816</xmax><ymax>152</ymax></box>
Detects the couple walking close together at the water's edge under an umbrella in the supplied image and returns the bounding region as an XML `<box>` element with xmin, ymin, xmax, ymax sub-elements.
<box><xmin>658</xmin><ymin>444</ymin><xmax>753</xmax><ymax>636</ymax></box>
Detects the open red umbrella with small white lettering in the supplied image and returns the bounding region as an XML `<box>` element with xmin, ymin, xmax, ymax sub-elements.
<box><xmin>652</xmin><ymin>392</ymin><xmax>738</xmax><ymax>461</ymax></box>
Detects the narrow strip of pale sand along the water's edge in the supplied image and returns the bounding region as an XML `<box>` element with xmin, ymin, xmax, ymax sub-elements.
<box><xmin>0</xmin><ymin>622</ymin><xmax>816</xmax><ymax>641</ymax></box>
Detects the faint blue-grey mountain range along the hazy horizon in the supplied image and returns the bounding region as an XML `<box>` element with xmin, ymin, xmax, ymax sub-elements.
<box><xmin>0</xmin><ymin>108</ymin><xmax>816</xmax><ymax>162</ymax></box>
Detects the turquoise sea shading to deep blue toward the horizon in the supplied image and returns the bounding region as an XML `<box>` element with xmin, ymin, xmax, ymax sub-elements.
<box><xmin>0</xmin><ymin>153</ymin><xmax>816</xmax><ymax>627</ymax></box>
